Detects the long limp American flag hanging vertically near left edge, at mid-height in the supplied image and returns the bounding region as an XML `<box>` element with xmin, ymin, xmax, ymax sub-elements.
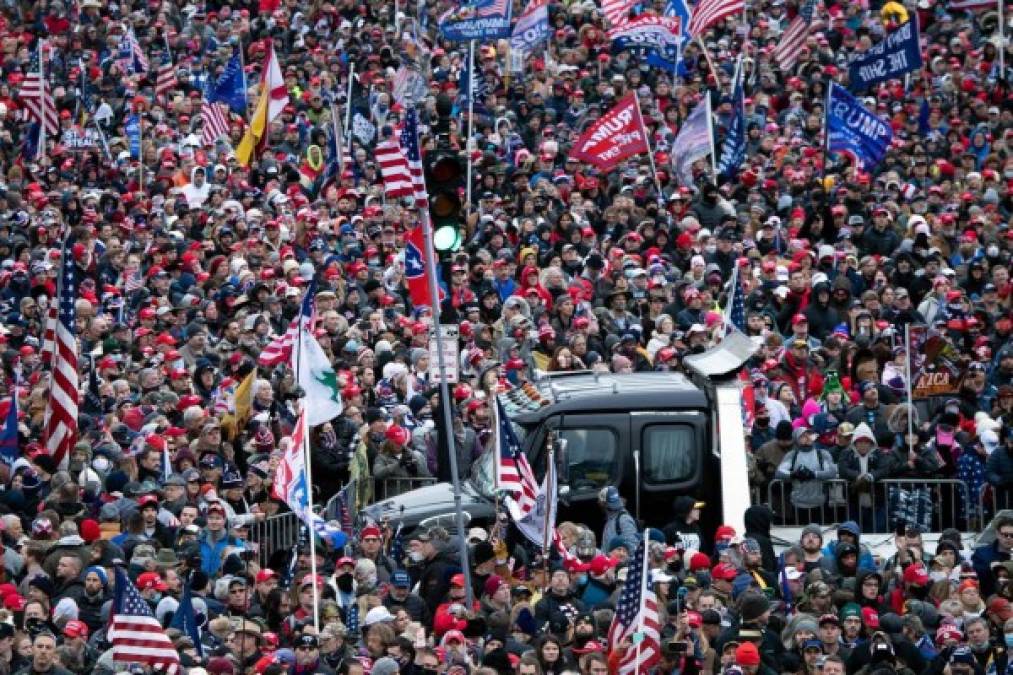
<box><xmin>44</xmin><ymin>245</ymin><xmax>78</xmax><ymax>467</ymax></box>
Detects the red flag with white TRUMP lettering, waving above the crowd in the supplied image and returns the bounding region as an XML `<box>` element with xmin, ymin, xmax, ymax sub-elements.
<box><xmin>570</xmin><ymin>92</ymin><xmax>648</xmax><ymax>171</ymax></box>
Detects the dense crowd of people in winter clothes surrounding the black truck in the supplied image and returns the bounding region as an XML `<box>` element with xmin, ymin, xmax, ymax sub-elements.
<box><xmin>0</xmin><ymin>0</ymin><xmax>1013</xmax><ymax>675</ymax></box>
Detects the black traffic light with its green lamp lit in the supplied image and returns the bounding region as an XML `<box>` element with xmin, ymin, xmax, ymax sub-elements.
<box><xmin>424</xmin><ymin>94</ymin><xmax>465</xmax><ymax>252</ymax></box>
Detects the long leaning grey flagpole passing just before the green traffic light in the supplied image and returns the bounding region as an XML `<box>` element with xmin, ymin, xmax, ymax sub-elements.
<box><xmin>418</xmin><ymin>208</ymin><xmax>475</xmax><ymax>610</ymax></box>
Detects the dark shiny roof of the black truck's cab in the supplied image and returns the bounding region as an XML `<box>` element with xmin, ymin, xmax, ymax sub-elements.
<box><xmin>504</xmin><ymin>372</ymin><xmax>708</xmax><ymax>423</ymax></box>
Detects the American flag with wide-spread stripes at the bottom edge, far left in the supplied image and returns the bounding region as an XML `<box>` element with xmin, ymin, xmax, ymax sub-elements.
<box><xmin>107</xmin><ymin>568</ymin><xmax>181</xmax><ymax>675</ymax></box>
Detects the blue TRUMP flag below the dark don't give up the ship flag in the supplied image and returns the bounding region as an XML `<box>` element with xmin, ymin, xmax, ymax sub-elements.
<box><xmin>827</xmin><ymin>82</ymin><xmax>893</xmax><ymax>170</ymax></box>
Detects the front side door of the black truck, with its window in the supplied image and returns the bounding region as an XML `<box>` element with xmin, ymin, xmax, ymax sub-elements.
<box><xmin>551</xmin><ymin>414</ymin><xmax>629</xmax><ymax>503</ymax></box>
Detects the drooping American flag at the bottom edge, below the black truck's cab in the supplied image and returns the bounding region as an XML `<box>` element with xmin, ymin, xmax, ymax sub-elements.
<box><xmin>609</xmin><ymin>535</ymin><xmax>661</xmax><ymax>675</ymax></box>
